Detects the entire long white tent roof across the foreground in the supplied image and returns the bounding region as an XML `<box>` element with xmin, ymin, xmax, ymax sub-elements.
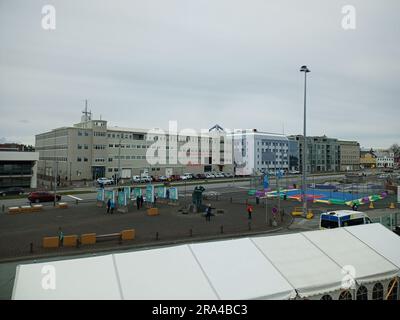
<box><xmin>12</xmin><ymin>224</ymin><xmax>400</xmax><ymax>300</ymax></box>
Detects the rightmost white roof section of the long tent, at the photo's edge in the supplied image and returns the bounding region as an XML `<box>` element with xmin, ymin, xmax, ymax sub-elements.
<box><xmin>345</xmin><ymin>223</ymin><xmax>400</xmax><ymax>275</ymax></box>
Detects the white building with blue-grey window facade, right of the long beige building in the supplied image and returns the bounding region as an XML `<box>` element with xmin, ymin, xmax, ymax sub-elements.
<box><xmin>233</xmin><ymin>129</ymin><xmax>289</xmax><ymax>175</ymax></box>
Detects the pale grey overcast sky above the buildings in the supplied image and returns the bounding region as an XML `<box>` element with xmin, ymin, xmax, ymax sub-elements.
<box><xmin>0</xmin><ymin>0</ymin><xmax>400</xmax><ymax>147</ymax></box>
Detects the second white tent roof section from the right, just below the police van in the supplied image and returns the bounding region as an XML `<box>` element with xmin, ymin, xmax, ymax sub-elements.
<box><xmin>303</xmin><ymin>228</ymin><xmax>398</xmax><ymax>284</ymax></box>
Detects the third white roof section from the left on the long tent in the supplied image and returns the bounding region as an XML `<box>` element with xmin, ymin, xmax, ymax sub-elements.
<box><xmin>190</xmin><ymin>238</ymin><xmax>296</xmax><ymax>300</ymax></box>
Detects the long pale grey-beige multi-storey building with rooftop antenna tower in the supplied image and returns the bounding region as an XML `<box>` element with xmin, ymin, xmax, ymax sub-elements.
<box><xmin>35</xmin><ymin>112</ymin><xmax>233</xmax><ymax>182</ymax></box>
